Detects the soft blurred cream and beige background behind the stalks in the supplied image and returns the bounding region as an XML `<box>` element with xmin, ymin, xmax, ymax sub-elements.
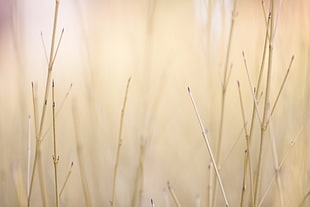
<box><xmin>0</xmin><ymin>0</ymin><xmax>310</xmax><ymax>206</ymax></box>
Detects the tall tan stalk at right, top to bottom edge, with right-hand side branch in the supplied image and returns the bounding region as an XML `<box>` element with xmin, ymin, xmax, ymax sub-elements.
<box><xmin>254</xmin><ymin>0</ymin><xmax>274</xmax><ymax>206</ymax></box>
